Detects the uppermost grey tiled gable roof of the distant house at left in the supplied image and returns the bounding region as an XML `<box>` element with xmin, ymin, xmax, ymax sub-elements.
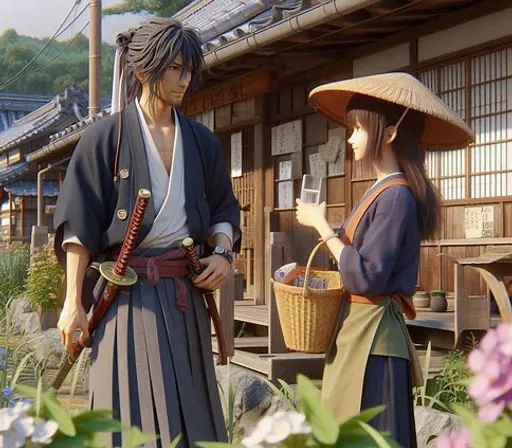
<box><xmin>0</xmin><ymin>85</ymin><xmax>87</xmax><ymax>153</ymax></box>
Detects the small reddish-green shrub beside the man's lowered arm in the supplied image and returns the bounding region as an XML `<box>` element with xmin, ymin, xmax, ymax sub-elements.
<box><xmin>27</xmin><ymin>245</ymin><xmax>64</xmax><ymax>312</ymax></box>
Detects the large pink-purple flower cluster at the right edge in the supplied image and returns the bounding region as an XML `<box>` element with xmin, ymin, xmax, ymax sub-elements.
<box><xmin>468</xmin><ymin>323</ymin><xmax>512</xmax><ymax>423</ymax></box>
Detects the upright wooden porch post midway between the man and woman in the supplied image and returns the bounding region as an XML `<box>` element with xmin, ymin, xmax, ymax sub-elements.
<box><xmin>253</xmin><ymin>123</ymin><xmax>266</xmax><ymax>305</ymax></box>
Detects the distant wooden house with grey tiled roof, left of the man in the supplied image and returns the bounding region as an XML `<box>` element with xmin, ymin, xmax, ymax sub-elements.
<box><xmin>0</xmin><ymin>86</ymin><xmax>87</xmax><ymax>242</ymax></box>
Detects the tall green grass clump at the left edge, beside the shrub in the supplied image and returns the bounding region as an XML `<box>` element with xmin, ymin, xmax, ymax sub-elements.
<box><xmin>0</xmin><ymin>243</ymin><xmax>30</xmax><ymax>309</ymax></box>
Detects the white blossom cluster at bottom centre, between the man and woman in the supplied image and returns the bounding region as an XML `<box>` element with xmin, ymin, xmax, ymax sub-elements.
<box><xmin>242</xmin><ymin>411</ymin><xmax>311</xmax><ymax>448</ymax></box>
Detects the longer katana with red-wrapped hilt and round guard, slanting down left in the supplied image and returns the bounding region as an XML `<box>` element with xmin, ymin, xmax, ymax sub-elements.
<box><xmin>52</xmin><ymin>188</ymin><xmax>151</xmax><ymax>390</ymax></box>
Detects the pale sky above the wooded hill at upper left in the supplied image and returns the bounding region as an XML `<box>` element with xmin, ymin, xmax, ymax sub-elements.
<box><xmin>0</xmin><ymin>0</ymin><xmax>152</xmax><ymax>44</ymax></box>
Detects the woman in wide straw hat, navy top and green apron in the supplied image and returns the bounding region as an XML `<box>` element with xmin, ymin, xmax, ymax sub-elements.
<box><xmin>297</xmin><ymin>73</ymin><xmax>472</xmax><ymax>447</ymax></box>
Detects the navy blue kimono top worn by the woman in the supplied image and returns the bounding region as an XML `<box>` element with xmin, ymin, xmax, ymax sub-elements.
<box><xmin>339</xmin><ymin>174</ymin><xmax>421</xmax><ymax>297</ymax></box>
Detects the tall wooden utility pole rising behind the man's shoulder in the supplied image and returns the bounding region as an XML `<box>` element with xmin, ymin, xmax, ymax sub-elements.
<box><xmin>89</xmin><ymin>0</ymin><xmax>101</xmax><ymax>117</ymax></box>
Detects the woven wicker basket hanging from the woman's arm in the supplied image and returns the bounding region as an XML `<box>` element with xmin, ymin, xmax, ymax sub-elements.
<box><xmin>272</xmin><ymin>241</ymin><xmax>343</xmax><ymax>353</ymax></box>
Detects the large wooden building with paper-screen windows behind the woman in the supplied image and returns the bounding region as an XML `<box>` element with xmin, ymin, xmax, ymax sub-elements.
<box><xmin>174</xmin><ymin>0</ymin><xmax>512</xmax><ymax>376</ymax></box>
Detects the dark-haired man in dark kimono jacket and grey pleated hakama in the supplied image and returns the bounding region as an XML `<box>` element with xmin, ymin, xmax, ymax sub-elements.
<box><xmin>55</xmin><ymin>19</ymin><xmax>240</xmax><ymax>447</ymax></box>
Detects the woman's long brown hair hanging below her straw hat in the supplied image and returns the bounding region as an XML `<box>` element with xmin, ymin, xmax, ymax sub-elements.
<box><xmin>347</xmin><ymin>95</ymin><xmax>441</xmax><ymax>240</ymax></box>
